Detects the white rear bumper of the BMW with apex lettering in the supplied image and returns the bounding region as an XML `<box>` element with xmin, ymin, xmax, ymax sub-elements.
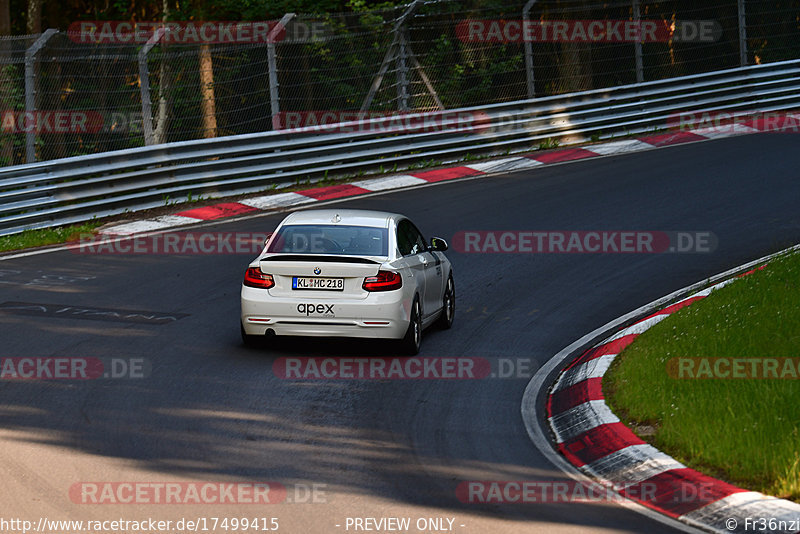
<box><xmin>241</xmin><ymin>286</ymin><xmax>410</xmax><ymax>339</ymax></box>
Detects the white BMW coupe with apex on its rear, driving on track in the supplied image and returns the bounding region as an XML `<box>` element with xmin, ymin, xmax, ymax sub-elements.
<box><xmin>241</xmin><ymin>209</ymin><xmax>456</xmax><ymax>354</ymax></box>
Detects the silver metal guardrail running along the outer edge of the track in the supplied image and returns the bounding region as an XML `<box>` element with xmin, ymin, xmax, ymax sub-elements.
<box><xmin>0</xmin><ymin>60</ymin><xmax>800</xmax><ymax>235</ymax></box>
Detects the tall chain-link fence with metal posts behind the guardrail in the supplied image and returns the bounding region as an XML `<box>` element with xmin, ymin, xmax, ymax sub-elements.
<box><xmin>0</xmin><ymin>0</ymin><xmax>800</xmax><ymax>165</ymax></box>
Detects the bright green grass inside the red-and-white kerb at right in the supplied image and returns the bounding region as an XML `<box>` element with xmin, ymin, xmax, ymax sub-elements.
<box><xmin>603</xmin><ymin>254</ymin><xmax>800</xmax><ymax>502</ymax></box>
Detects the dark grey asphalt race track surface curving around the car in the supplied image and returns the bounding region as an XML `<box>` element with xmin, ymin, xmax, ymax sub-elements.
<box><xmin>0</xmin><ymin>134</ymin><xmax>800</xmax><ymax>534</ymax></box>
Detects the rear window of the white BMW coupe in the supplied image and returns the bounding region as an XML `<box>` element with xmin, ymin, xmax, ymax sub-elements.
<box><xmin>267</xmin><ymin>224</ymin><xmax>389</xmax><ymax>256</ymax></box>
